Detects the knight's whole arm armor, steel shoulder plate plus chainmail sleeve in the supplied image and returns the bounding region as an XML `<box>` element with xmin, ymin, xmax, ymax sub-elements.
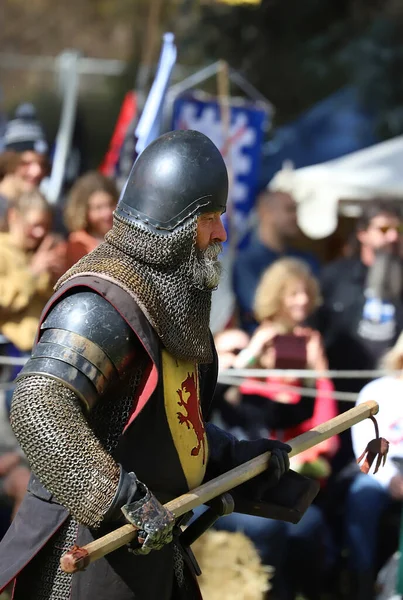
<box><xmin>11</xmin><ymin>292</ymin><xmax>144</xmax><ymax>528</ymax></box>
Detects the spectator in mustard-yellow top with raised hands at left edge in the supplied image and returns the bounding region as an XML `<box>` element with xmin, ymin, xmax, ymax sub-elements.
<box><xmin>0</xmin><ymin>191</ymin><xmax>63</xmax><ymax>535</ymax></box>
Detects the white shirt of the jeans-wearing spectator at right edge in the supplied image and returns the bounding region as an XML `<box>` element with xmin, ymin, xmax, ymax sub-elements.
<box><xmin>351</xmin><ymin>376</ymin><xmax>403</xmax><ymax>488</ymax></box>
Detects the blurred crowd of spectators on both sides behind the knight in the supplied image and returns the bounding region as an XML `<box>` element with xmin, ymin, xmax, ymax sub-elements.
<box><xmin>0</xmin><ymin>105</ymin><xmax>403</xmax><ymax>600</ymax></box>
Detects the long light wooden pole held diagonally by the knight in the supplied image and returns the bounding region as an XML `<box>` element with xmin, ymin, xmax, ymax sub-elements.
<box><xmin>60</xmin><ymin>401</ymin><xmax>379</xmax><ymax>573</ymax></box>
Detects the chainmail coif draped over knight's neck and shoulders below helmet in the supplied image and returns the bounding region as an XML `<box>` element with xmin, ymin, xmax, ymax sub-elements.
<box><xmin>56</xmin><ymin>215</ymin><xmax>213</xmax><ymax>363</ymax></box>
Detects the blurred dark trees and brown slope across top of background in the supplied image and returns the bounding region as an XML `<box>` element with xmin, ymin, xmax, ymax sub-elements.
<box><xmin>4</xmin><ymin>0</ymin><xmax>403</xmax><ymax>154</ymax></box>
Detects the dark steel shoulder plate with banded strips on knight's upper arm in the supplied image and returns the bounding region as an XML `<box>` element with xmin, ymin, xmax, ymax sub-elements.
<box><xmin>19</xmin><ymin>291</ymin><xmax>140</xmax><ymax>408</ymax></box>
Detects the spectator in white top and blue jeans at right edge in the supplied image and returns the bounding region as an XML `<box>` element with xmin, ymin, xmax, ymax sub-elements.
<box><xmin>345</xmin><ymin>334</ymin><xmax>403</xmax><ymax>600</ymax></box>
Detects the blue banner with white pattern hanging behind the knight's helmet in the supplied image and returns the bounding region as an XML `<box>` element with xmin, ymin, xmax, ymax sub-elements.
<box><xmin>172</xmin><ymin>95</ymin><xmax>269</xmax><ymax>243</ymax></box>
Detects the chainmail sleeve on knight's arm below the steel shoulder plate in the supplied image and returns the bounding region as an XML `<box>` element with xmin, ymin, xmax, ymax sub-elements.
<box><xmin>11</xmin><ymin>375</ymin><xmax>120</xmax><ymax>528</ymax></box>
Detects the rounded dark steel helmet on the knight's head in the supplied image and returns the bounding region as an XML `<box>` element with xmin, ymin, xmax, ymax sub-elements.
<box><xmin>115</xmin><ymin>131</ymin><xmax>228</xmax><ymax>233</ymax></box>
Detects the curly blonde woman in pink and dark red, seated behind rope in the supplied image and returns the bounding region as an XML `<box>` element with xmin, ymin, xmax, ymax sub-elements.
<box><xmin>208</xmin><ymin>258</ymin><xmax>337</xmax><ymax>600</ymax></box>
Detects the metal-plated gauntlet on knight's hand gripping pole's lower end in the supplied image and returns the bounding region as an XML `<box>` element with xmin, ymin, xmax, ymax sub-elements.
<box><xmin>104</xmin><ymin>467</ymin><xmax>175</xmax><ymax>555</ymax></box>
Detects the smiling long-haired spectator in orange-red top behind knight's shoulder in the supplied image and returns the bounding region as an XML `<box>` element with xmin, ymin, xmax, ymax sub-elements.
<box><xmin>65</xmin><ymin>171</ymin><xmax>118</xmax><ymax>267</ymax></box>
